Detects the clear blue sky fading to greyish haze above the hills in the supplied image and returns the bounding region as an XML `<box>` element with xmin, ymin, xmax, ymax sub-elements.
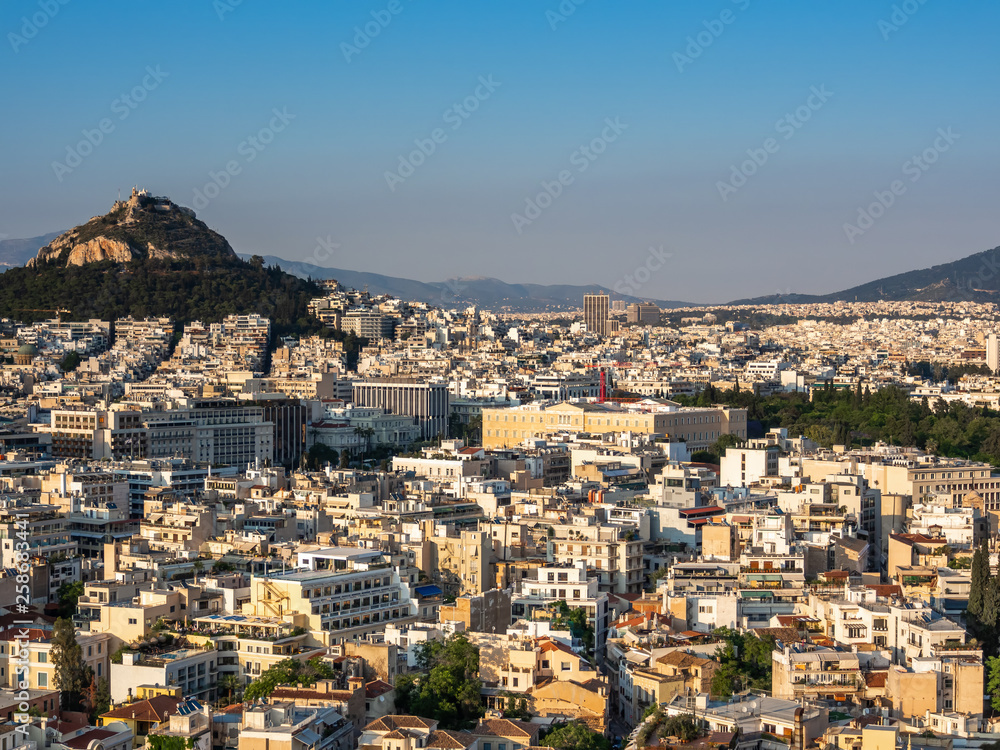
<box><xmin>0</xmin><ymin>0</ymin><xmax>1000</xmax><ymax>302</ymax></box>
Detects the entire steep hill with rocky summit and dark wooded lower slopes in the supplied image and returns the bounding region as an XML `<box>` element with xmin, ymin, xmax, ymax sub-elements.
<box><xmin>0</xmin><ymin>190</ymin><xmax>324</xmax><ymax>336</ymax></box>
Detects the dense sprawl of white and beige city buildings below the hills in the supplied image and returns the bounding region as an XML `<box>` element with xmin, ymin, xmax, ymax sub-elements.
<box><xmin>0</xmin><ymin>242</ymin><xmax>1000</xmax><ymax>750</ymax></box>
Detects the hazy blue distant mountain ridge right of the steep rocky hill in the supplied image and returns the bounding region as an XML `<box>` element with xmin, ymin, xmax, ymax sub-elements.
<box><xmin>240</xmin><ymin>255</ymin><xmax>693</xmax><ymax>312</ymax></box>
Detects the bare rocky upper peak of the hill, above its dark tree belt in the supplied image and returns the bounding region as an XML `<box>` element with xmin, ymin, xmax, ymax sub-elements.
<box><xmin>26</xmin><ymin>188</ymin><xmax>236</xmax><ymax>268</ymax></box>
